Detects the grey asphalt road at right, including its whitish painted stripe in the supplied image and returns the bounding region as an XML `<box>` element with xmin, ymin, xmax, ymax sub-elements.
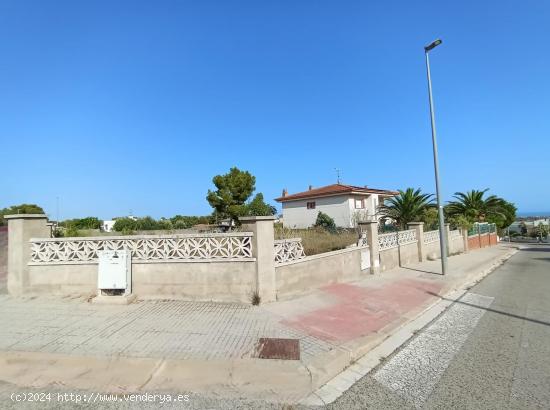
<box><xmin>327</xmin><ymin>244</ymin><xmax>550</xmax><ymax>410</ymax></box>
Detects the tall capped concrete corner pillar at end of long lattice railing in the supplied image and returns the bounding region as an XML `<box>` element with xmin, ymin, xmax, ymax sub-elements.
<box><xmin>239</xmin><ymin>216</ymin><xmax>277</xmax><ymax>302</ymax></box>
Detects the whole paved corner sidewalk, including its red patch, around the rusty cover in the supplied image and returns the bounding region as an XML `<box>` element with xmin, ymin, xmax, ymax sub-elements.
<box><xmin>0</xmin><ymin>242</ymin><xmax>510</xmax><ymax>402</ymax></box>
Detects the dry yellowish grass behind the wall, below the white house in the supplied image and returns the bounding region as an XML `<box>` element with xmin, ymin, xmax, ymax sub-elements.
<box><xmin>275</xmin><ymin>226</ymin><xmax>358</xmax><ymax>256</ymax></box>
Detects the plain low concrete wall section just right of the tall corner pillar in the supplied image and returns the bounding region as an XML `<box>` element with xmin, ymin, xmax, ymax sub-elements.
<box><xmin>275</xmin><ymin>247</ymin><xmax>370</xmax><ymax>299</ymax></box>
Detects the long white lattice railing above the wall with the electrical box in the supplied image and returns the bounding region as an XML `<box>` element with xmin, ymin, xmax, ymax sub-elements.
<box><xmin>29</xmin><ymin>232</ymin><xmax>253</xmax><ymax>265</ymax></box>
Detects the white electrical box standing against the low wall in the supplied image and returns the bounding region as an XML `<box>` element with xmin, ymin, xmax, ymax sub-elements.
<box><xmin>97</xmin><ymin>250</ymin><xmax>132</xmax><ymax>295</ymax></box>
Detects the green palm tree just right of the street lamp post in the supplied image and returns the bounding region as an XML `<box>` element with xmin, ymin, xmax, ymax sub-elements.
<box><xmin>445</xmin><ymin>189</ymin><xmax>506</xmax><ymax>222</ymax></box>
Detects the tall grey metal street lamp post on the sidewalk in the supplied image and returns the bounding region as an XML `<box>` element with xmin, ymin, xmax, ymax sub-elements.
<box><xmin>424</xmin><ymin>39</ymin><xmax>447</xmax><ymax>275</ymax></box>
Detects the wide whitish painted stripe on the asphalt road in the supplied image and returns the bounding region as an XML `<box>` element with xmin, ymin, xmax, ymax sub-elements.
<box><xmin>373</xmin><ymin>293</ymin><xmax>494</xmax><ymax>408</ymax></box>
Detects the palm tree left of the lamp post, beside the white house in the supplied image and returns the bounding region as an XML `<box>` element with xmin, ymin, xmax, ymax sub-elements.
<box><xmin>379</xmin><ymin>188</ymin><xmax>435</xmax><ymax>229</ymax></box>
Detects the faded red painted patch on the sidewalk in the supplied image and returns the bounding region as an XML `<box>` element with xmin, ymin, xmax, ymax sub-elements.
<box><xmin>283</xmin><ymin>279</ymin><xmax>441</xmax><ymax>342</ymax></box>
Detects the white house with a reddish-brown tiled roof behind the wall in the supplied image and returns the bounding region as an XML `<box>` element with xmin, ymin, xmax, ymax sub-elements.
<box><xmin>275</xmin><ymin>183</ymin><xmax>397</xmax><ymax>228</ymax></box>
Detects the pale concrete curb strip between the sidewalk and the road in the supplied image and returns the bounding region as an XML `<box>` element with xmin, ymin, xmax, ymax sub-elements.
<box><xmin>300</xmin><ymin>248</ymin><xmax>519</xmax><ymax>406</ymax></box>
